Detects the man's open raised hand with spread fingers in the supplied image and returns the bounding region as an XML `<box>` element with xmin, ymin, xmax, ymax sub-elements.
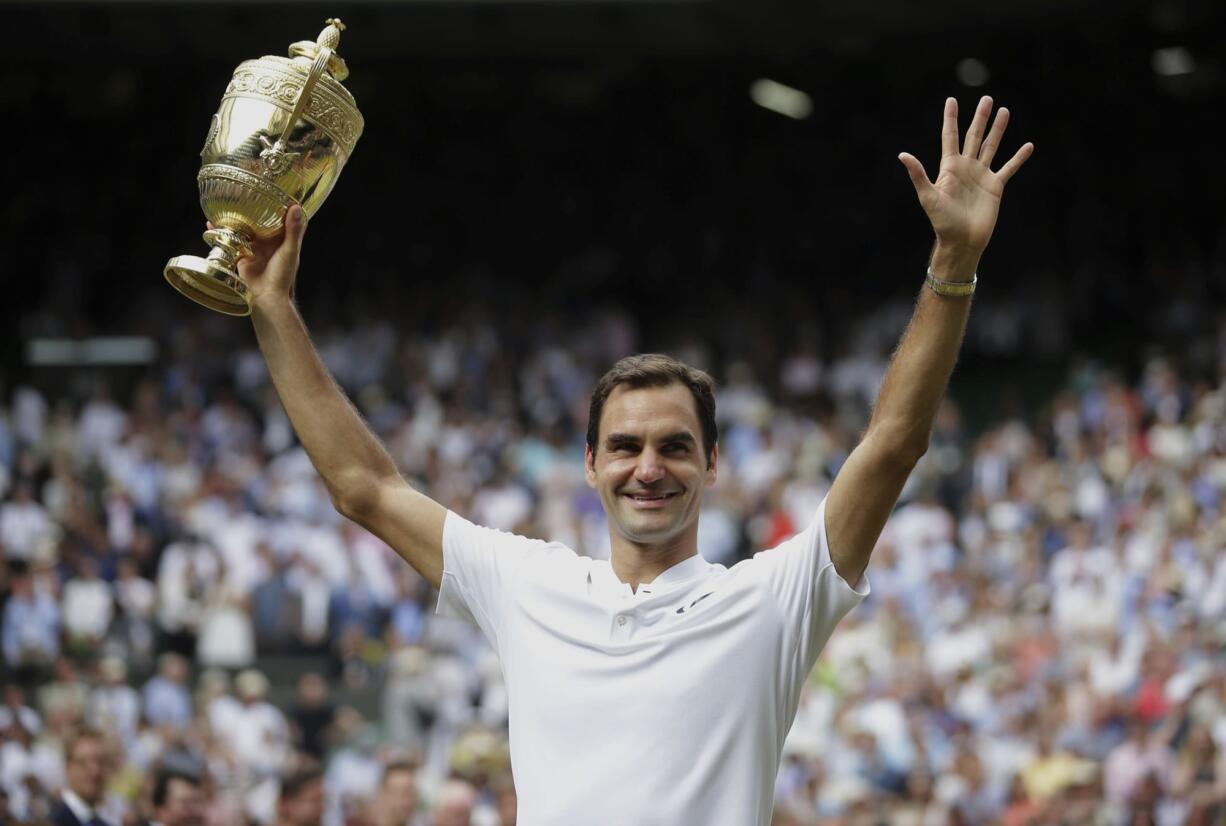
<box><xmin>899</xmin><ymin>97</ymin><xmax>1035</xmax><ymax>257</ymax></box>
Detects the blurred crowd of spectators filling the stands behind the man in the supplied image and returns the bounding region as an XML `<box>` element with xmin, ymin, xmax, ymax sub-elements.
<box><xmin>0</xmin><ymin>284</ymin><xmax>1226</xmax><ymax>826</ymax></box>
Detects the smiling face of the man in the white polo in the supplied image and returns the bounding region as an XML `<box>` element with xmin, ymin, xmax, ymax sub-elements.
<box><xmin>587</xmin><ymin>384</ymin><xmax>718</xmax><ymax>544</ymax></box>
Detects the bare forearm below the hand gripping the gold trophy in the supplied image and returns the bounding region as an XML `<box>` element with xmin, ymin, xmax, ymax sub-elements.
<box><xmin>251</xmin><ymin>297</ymin><xmax>397</xmax><ymax>511</ymax></box>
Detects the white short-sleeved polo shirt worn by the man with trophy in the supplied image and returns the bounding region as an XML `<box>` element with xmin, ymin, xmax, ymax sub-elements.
<box><xmin>439</xmin><ymin>492</ymin><xmax>868</xmax><ymax>826</ymax></box>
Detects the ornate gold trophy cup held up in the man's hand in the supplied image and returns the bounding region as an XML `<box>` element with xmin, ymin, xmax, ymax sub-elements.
<box><xmin>164</xmin><ymin>18</ymin><xmax>363</xmax><ymax>315</ymax></box>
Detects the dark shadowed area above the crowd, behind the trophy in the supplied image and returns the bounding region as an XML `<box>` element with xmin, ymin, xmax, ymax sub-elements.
<box><xmin>0</xmin><ymin>0</ymin><xmax>1226</xmax><ymax>419</ymax></box>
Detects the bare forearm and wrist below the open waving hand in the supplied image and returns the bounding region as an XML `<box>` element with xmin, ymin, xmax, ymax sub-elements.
<box><xmin>868</xmin><ymin>237</ymin><xmax>980</xmax><ymax>460</ymax></box>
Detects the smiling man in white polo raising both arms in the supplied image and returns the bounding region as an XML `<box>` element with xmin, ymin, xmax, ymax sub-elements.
<box><xmin>239</xmin><ymin>98</ymin><xmax>1034</xmax><ymax>826</ymax></box>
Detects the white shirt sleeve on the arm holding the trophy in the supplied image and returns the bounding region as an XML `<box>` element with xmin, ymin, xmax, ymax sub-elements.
<box><xmin>436</xmin><ymin>511</ymin><xmax>550</xmax><ymax>651</ymax></box>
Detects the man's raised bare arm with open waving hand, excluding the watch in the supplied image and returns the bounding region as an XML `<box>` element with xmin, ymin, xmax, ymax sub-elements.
<box><xmin>826</xmin><ymin>97</ymin><xmax>1035</xmax><ymax>585</ymax></box>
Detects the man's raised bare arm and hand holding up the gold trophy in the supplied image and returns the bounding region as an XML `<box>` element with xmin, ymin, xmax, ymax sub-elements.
<box><xmin>239</xmin><ymin>206</ymin><xmax>446</xmax><ymax>587</ymax></box>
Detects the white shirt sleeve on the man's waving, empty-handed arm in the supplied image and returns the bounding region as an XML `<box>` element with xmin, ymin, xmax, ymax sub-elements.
<box><xmin>754</xmin><ymin>499</ymin><xmax>869</xmax><ymax>691</ymax></box>
